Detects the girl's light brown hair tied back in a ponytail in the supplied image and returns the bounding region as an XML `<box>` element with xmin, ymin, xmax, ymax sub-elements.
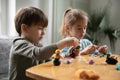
<box><xmin>61</xmin><ymin>8</ymin><xmax>88</xmax><ymax>38</ymax></box>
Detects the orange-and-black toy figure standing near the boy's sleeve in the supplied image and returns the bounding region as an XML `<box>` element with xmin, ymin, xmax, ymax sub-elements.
<box><xmin>52</xmin><ymin>49</ymin><xmax>63</xmax><ymax>66</ymax></box>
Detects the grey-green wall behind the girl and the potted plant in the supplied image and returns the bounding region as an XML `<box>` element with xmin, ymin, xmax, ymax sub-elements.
<box><xmin>52</xmin><ymin>0</ymin><xmax>120</xmax><ymax>53</ymax></box>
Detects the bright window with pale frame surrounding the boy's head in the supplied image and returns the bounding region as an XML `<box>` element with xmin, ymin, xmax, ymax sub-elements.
<box><xmin>0</xmin><ymin>0</ymin><xmax>53</xmax><ymax>45</ymax></box>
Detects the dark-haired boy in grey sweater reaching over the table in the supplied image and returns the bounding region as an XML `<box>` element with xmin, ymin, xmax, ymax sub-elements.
<box><xmin>9</xmin><ymin>7</ymin><xmax>79</xmax><ymax>80</ymax></box>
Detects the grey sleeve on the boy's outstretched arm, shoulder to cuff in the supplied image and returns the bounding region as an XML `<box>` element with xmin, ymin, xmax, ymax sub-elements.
<box><xmin>12</xmin><ymin>39</ymin><xmax>57</xmax><ymax>60</ymax></box>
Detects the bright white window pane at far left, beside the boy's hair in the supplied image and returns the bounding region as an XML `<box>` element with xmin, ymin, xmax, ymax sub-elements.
<box><xmin>0</xmin><ymin>0</ymin><xmax>16</xmax><ymax>36</ymax></box>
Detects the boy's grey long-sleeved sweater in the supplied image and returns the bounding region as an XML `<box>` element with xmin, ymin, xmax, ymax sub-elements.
<box><xmin>9</xmin><ymin>38</ymin><xmax>57</xmax><ymax>80</ymax></box>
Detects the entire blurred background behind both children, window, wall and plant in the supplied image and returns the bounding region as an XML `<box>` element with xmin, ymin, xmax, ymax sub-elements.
<box><xmin>0</xmin><ymin>0</ymin><xmax>120</xmax><ymax>54</ymax></box>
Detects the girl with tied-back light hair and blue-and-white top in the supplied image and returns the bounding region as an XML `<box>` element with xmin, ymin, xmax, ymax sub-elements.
<box><xmin>61</xmin><ymin>9</ymin><xmax>108</xmax><ymax>56</ymax></box>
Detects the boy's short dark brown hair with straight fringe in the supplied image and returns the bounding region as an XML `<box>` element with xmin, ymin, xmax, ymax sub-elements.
<box><xmin>14</xmin><ymin>7</ymin><xmax>48</xmax><ymax>36</ymax></box>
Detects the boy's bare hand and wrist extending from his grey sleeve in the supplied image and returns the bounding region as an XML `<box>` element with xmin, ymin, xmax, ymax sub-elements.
<box><xmin>56</xmin><ymin>37</ymin><xmax>80</xmax><ymax>49</ymax></box>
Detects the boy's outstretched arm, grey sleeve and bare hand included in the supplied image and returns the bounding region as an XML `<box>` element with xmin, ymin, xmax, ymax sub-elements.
<box><xmin>13</xmin><ymin>38</ymin><xmax>79</xmax><ymax>60</ymax></box>
